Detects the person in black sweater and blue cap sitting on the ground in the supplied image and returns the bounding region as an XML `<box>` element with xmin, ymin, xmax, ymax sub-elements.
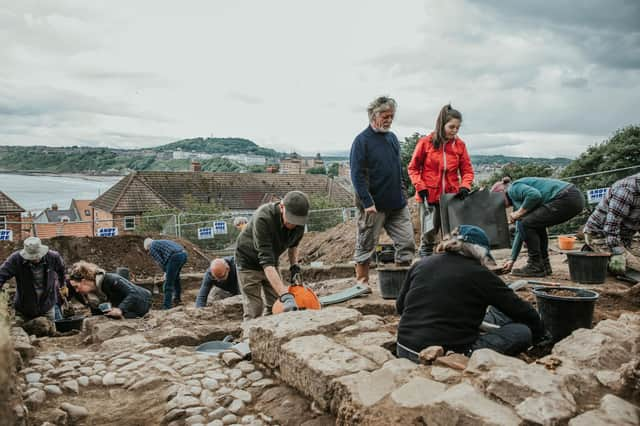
<box><xmin>396</xmin><ymin>225</ymin><xmax>545</xmax><ymax>362</ymax></box>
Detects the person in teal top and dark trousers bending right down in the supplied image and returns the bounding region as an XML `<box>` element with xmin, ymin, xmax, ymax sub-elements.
<box><xmin>503</xmin><ymin>177</ymin><xmax>584</xmax><ymax>277</ymax></box>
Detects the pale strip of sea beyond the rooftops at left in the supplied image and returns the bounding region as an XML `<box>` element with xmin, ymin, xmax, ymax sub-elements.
<box><xmin>0</xmin><ymin>173</ymin><xmax>123</xmax><ymax>214</ymax></box>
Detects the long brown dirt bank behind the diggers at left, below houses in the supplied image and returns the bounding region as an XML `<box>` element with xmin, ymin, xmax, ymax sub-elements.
<box><xmin>0</xmin><ymin>235</ymin><xmax>209</xmax><ymax>278</ymax></box>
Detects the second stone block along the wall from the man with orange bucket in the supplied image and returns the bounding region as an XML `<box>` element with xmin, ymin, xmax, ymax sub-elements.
<box><xmin>280</xmin><ymin>334</ymin><xmax>378</xmax><ymax>409</ymax></box>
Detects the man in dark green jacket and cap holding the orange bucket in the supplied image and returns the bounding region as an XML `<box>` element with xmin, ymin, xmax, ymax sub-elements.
<box><xmin>235</xmin><ymin>191</ymin><xmax>309</xmax><ymax>320</ymax></box>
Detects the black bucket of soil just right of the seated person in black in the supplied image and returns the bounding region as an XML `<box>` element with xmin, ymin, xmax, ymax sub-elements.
<box><xmin>532</xmin><ymin>287</ymin><xmax>598</xmax><ymax>343</ymax></box>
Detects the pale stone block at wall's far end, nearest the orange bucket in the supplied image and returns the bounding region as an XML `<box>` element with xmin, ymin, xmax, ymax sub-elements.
<box><xmin>243</xmin><ymin>307</ymin><xmax>362</xmax><ymax>368</ymax></box>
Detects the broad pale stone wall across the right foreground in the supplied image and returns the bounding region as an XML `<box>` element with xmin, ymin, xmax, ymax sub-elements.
<box><xmin>243</xmin><ymin>307</ymin><xmax>640</xmax><ymax>426</ymax></box>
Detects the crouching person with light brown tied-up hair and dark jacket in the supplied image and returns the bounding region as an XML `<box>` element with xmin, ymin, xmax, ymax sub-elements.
<box><xmin>69</xmin><ymin>261</ymin><xmax>151</xmax><ymax>318</ymax></box>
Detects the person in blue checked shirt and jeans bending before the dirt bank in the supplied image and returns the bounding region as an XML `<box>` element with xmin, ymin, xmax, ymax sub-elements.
<box><xmin>143</xmin><ymin>238</ymin><xmax>187</xmax><ymax>309</ymax></box>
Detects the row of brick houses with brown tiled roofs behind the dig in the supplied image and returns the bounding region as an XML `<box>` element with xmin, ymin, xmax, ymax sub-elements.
<box><xmin>0</xmin><ymin>168</ymin><xmax>353</xmax><ymax>239</ymax></box>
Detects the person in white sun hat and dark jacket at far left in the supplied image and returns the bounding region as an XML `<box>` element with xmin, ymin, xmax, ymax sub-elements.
<box><xmin>0</xmin><ymin>237</ymin><xmax>64</xmax><ymax>325</ymax></box>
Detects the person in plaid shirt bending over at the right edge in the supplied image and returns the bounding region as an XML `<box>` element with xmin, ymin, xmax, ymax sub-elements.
<box><xmin>584</xmin><ymin>173</ymin><xmax>640</xmax><ymax>274</ymax></box>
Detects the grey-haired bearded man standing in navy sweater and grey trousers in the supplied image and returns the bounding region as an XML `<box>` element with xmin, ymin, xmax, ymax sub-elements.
<box><xmin>349</xmin><ymin>96</ymin><xmax>415</xmax><ymax>285</ymax></box>
